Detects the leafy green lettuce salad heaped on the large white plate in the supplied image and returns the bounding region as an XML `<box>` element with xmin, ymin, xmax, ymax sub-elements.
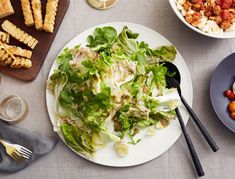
<box><xmin>48</xmin><ymin>26</ymin><xmax>180</xmax><ymax>156</ymax></box>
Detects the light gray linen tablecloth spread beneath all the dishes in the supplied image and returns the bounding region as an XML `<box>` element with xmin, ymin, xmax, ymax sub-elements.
<box><xmin>0</xmin><ymin>0</ymin><xmax>235</xmax><ymax>179</ymax></box>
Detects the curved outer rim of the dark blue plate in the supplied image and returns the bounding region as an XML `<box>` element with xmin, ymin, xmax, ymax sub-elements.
<box><xmin>210</xmin><ymin>52</ymin><xmax>235</xmax><ymax>133</ymax></box>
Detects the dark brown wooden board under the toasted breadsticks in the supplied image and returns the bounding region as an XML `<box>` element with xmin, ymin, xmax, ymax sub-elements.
<box><xmin>0</xmin><ymin>0</ymin><xmax>70</xmax><ymax>81</ymax></box>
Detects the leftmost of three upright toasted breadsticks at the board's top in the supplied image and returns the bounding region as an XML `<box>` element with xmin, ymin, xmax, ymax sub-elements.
<box><xmin>21</xmin><ymin>0</ymin><xmax>34</xmax><ymax>26</ymax></box>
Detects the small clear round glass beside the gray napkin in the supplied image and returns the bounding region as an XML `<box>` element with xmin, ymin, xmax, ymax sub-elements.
<box><xmin>0</xmin><ymin>94</ymin><xmax>28</xmax><ymax>123</ymax></box>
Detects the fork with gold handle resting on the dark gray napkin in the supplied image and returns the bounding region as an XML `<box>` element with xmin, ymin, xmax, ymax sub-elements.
<box><xmin>0</xmin><ymin>139</ymin><xmax>32</xmax><ymax>160</ymax></box>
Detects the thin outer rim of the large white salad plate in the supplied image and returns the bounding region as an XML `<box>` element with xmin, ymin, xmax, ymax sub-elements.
<box><xmin>45</xmin><ymin>21</ymin><xmax>193</xmax><ymax>168</ymax></box>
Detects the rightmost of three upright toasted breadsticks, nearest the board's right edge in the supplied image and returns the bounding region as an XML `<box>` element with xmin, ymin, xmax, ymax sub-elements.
<box><xmin>44</xmin><ymin>0</ymin><xmax>59</xmax><ymax>33</ymax></box>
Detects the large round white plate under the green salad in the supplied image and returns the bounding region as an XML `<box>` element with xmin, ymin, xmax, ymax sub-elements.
<box><xmin>46</xmin><ymin>22</ymin><xmax>193</xmax><ymax>167</ymax></box>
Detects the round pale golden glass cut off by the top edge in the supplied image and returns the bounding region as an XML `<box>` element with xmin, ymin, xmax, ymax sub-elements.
<box><xmin>86</xmin><ymin>0</ymin><xmax>118</xmax><ymax>10</ymax></box>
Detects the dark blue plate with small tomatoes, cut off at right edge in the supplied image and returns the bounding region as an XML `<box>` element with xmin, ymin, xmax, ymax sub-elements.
<box><xmin>210</xmin><ymin>53</ymin><xmax>235</xmax><ymax>132</ymax></box>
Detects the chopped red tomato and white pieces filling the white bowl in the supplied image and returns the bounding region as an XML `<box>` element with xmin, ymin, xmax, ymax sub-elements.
<box><xmin>177</xmin><ymin>0</ymin><xmax>235</xmax><ymax>33</ymax></box>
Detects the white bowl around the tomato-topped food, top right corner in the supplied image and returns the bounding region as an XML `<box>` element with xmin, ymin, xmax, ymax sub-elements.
<box><xmin>169</xmin><ymin>0</ymin><xmax>235</xmax><ymax>39</ymax></box>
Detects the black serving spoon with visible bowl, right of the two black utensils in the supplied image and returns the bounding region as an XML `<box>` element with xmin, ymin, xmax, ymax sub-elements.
<box><xmin>164</xmin><ymin>62</ymin><xmax>219</xmax><ymax>152</ymax></box>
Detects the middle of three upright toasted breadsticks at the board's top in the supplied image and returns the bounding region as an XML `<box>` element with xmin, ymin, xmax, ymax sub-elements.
<box><xmin>31</xmin><ymin>0</ymin><xmax>43</xmax><ymax>30</ymax></box>
